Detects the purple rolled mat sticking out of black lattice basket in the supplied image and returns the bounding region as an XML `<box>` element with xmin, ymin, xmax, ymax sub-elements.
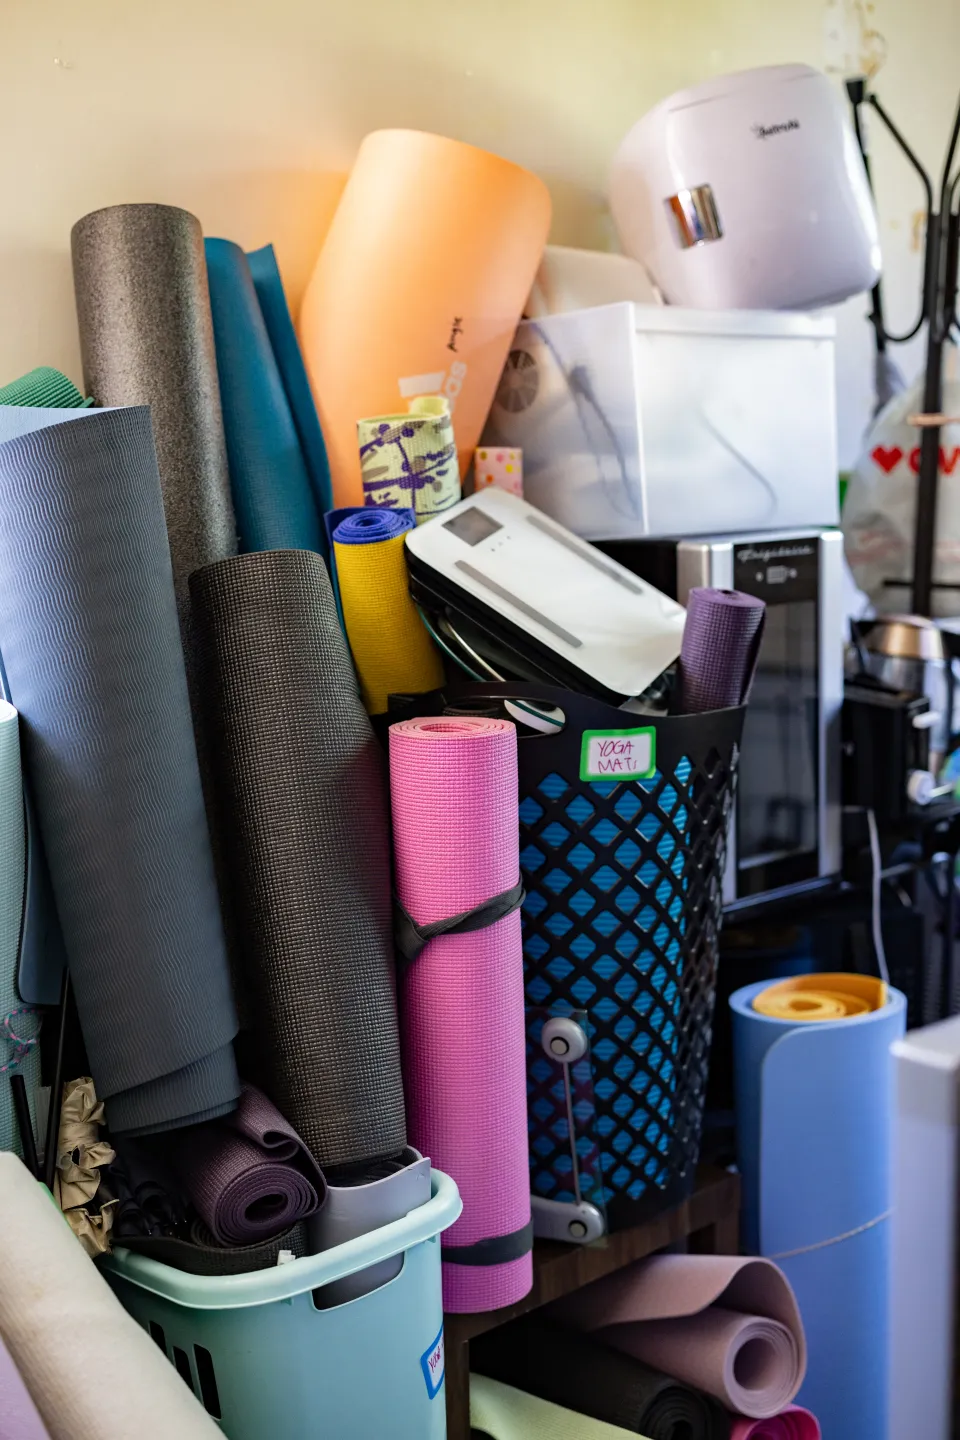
<box><xmin>678</xmin><ymin>585</ymin><xmax>767</xmax><ymax>714</ymax></box>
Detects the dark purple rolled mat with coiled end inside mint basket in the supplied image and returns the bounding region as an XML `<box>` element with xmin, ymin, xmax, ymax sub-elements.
<box><xmin>170</xmin><ymin>1084</ymin><xmax>327</xmax><ymax>1246</ymax></box>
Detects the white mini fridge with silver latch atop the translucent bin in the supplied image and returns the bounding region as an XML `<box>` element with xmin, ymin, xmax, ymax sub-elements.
<box><xmin>610</xmin><ymin>65</ymin><xmax>881</xmax><ymax>310</ymax></box>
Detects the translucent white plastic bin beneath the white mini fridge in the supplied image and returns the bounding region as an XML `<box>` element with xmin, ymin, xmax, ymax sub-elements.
<box><xmin>484</xmin><ymin>302</ymin><xmax>838</xmax><ymax>540</ymax></box>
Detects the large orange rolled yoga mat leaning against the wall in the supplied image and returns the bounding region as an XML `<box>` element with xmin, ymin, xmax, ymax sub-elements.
<box><xmin>299</xmin><ymin>130</ymin><xmax>550</xmax><ymax>505</ymax></box>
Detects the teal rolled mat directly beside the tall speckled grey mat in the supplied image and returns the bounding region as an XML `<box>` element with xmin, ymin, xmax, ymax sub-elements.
<box><xmin>204</xmin><ymin>240</ymin><xmax>327</xmax><ymax>552</ymax></box>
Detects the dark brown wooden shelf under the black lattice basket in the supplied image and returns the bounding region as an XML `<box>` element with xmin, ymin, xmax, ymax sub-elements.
<box><xmin>443</xmin><ymin>1169</ymin><xmax>740</xmax><ymax>1440</ymax></box>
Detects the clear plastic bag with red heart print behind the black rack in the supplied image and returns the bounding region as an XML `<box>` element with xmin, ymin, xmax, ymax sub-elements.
<box><xmin>841</xmin><ymin>347</ymin><xmax>960</xmax><ymax>616</ymax></box>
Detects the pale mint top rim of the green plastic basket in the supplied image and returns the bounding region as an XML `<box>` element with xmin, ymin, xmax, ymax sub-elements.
<box><xmin>102</xmin><ymin>1169</ymin><xmax>463</xmax><ymax>1310</ymax></box>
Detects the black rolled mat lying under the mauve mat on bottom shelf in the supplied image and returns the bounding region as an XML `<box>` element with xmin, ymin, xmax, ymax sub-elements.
<box><xmin>471</xmin><ymin>1316</ymin><xmax>730</xmax><ymax>1440</ymax></box>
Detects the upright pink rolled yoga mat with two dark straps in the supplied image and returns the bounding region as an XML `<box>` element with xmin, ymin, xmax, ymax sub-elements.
<box><xmin>390</xmin><ymin>717</ymin><xmax>533</xmax><ymax>1312</ymax></box>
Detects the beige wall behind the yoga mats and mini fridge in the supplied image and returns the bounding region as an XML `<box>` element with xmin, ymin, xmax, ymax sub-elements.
<box><xmin>0</xmin><ymin>0</ymin><xmax>960</xmax><ymax>461</ymax></box>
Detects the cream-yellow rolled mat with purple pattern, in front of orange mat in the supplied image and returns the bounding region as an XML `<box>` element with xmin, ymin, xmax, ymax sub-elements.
<box><xmin>357</xmin><ymin>395</ymin><xmax>461</xmax><ymax>524</ymax></box>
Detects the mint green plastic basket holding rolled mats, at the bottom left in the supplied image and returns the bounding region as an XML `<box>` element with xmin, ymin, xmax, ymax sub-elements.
<box><xmin>102</xmin><ymin>1171</ymin><xmax>462</xmax><ymax>1440</ymax></box>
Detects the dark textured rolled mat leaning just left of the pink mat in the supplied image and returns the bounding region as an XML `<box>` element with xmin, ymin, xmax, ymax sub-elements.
<box><xmin>190</xmin><ymin>550</ymin><xmax>406</xmax><ymax>1169</ymax></box>
